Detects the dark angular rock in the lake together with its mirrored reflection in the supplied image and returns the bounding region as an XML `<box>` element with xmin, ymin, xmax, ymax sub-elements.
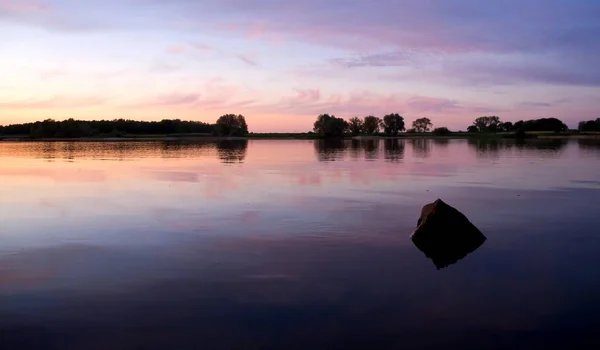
<box><xmin>411</xmin><ymin>199</ymin><xmax>486</xmax><ymax>270</ymax></box>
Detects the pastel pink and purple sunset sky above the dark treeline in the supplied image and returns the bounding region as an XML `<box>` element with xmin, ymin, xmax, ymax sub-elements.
<box><xmin>0</xmin><ymin>0</ymin><xmax>600</xmax><ymax>132</ymax></box>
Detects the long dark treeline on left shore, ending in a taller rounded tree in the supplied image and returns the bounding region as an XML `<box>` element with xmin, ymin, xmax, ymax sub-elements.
<box><xmin>0</xmin><ymin>114</ymin><xmax>248</xmax><ymax>138</ymax></box>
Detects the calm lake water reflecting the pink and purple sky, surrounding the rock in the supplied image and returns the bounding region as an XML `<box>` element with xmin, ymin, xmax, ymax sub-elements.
<box><xmin>0</xmin><ymin>140</ymin><xmax>600</xmax><ymax>350</ymax></box>
